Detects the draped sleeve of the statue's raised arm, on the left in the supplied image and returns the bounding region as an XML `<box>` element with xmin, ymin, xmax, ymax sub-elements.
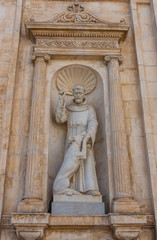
<box><xmin>55</xmin><ymin>102</ymin><xmax>68</xmax><ymax>123</ymax></box>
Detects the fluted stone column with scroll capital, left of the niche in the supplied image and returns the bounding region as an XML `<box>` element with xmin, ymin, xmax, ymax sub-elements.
<box><xmin>18</xmin><ymin>53</ymin><xmax>50</xmax><ymax>213</ymax></box>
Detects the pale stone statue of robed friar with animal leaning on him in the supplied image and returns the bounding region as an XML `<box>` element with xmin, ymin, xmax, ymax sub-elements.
<box><xmin>53</xmin><ymin>84</ymin><xmax>100</xmax><ymax>195</ymax></box>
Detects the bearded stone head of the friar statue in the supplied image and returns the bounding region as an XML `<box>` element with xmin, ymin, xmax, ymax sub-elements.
<box><xmin>73</xmin><ymin>84</ymin><xmax>85</xmax><ymax>104</ymax></box>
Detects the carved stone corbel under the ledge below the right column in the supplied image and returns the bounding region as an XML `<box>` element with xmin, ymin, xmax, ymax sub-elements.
<box><xmin>113</xmin><ymin>226</ymin><xmax>141</xmax><ymax>240</ymax></box>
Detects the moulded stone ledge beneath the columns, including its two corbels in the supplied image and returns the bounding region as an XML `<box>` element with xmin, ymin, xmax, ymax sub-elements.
<box><xmin>8</xmin><ymin>213</ymin><xmax>154</xmax><ymax>240</ymax></box>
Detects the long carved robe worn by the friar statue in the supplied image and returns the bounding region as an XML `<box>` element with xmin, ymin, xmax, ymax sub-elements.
<box><xmin>55</xmin><ymin>101</ymin><xmax>99</xmax><ymax>194</ymax></box>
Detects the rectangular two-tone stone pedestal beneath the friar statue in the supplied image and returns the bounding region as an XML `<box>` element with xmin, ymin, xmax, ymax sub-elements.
<box><xmin>51</xmin><ymin>195</ymin><xmax>105</xmax><ymax>216</ymax></box>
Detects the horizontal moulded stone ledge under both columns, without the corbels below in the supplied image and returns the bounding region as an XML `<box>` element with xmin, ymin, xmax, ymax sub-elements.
<box><xmin>8</xmin><ymin>213</ymin><xmax>154</xmax><ymax>228</ymax></box>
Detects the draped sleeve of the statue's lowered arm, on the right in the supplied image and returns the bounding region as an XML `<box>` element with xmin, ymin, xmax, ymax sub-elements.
<box><xmin>87</xmin><ymin>106</ymin><xmax>98</xmax><ymax>146</ymax></box>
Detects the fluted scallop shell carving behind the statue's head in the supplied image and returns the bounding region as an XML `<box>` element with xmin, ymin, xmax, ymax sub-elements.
<box><xmin>56</xmin><ymin>65</ymin><xmax>97</xmax><ymax>95</ymax></box>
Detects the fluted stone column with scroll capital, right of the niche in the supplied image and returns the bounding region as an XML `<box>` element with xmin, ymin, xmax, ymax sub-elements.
<box><xmin>104</xmin><ymin>55</ymin><xmax>140</xmax><ymax>213</ymax></box>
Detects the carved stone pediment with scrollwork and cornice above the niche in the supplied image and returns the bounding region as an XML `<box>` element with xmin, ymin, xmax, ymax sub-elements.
<box><xmin>25</xmin><ymin>2</ymin><xmax>129</xmax><ymax>54</ymax></box>
